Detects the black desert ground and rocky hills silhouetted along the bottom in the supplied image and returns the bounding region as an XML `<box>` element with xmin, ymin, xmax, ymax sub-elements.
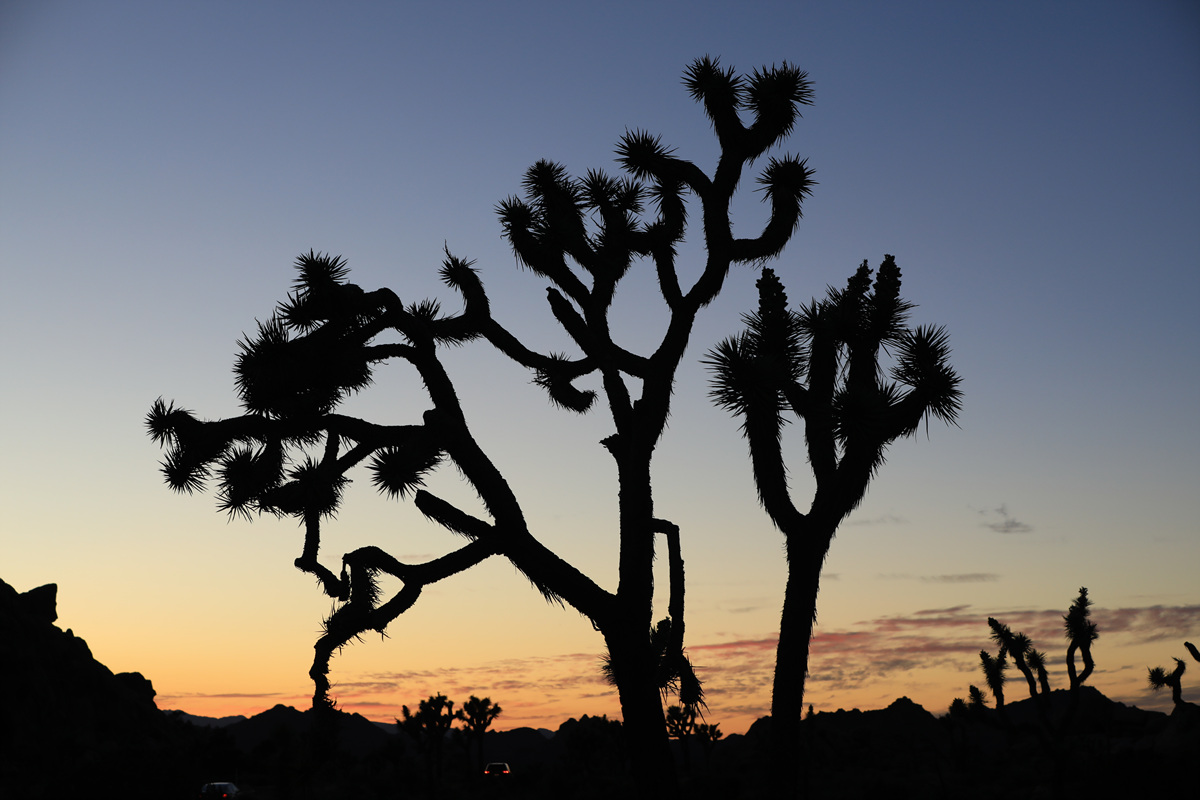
<box><xmin>0</xmin><ymin>581</ymin><xmax>1200</xmax><ymax>800</ymax></box>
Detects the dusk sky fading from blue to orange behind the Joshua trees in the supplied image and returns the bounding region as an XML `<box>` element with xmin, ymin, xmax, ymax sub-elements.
<box><xmin>0</xmin><ymin>0</ymin><xmax>1200</xmax><ymax>733</ymax></box>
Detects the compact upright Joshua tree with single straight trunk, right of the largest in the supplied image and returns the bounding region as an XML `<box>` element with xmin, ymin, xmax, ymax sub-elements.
<box><xmin>707</xmin><ymin>255</ymin><xmax>962</xmax><ymax>775</ymax></box>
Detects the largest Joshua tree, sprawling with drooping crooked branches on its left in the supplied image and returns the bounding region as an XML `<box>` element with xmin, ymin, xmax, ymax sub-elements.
<box><xmin>148</xmin><ymin>58</ymin><xmax>812</xmax><ymax>798</ymax></box>
